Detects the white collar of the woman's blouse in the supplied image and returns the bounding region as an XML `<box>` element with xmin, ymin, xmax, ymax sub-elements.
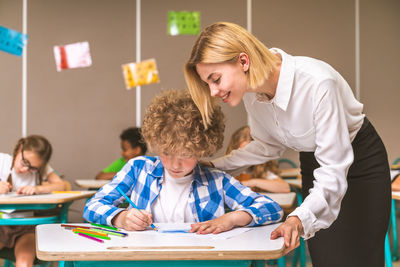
<box><xmin>270</xmin><ymin>48</ymin><xmax>295</xmax><ymax>111</ymax></box>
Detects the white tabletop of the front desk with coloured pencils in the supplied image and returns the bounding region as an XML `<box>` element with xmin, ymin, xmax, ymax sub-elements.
<box><xmin>36</xmin><ymin>224</ymin><xmax>284</xmax><ymax>261</ymax></box>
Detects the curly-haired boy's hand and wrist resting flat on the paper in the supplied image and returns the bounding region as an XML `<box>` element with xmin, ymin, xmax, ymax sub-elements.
<box><xmin>190</xmin><ymin>210</ymin><xmax>252</xmax><ymax>234</ymax></box>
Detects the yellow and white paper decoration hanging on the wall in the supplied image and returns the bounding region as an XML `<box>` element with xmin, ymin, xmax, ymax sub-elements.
<box><xmin>122</xmin><ymin>59</ymin><xmax>160</xmax><ymax>90</ymax></box>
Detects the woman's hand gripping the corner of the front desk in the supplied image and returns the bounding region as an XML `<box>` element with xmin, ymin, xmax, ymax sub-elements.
<box><xmin>271</xmin><ymin>216</ymin><xmax>304</xmax><ymax>255</ymax></box>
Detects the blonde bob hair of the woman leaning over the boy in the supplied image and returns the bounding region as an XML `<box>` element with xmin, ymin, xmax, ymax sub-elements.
<box><xmin>184</xmin><ymin>22</ymin><xmax>278</xmax><ymax>127</ymax></box>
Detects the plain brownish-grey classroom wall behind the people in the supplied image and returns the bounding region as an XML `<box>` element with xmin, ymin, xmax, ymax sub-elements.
<box><xmin>0</xmin><ymin>0</ymin><xmax>400</xmax><ymax>221</ymax></box>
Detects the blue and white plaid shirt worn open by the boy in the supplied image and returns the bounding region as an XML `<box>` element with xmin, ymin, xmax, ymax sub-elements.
<box><xmin>83</xmin><ymin>157</ymin><xmax>283</xmax><ymax>226</ymax></box>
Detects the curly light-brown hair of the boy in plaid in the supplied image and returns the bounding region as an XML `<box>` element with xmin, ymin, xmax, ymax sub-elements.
<box><xmin>142</xmin><ymin>90</ymin><xmax>225</xmax><ymax>158</ymax></box>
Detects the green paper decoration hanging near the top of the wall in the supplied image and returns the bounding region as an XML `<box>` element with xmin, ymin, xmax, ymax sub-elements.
<box><xmin>167</xmin><ymin>11</ymin><xmax>200</xmax><ymax>35</ymax></box>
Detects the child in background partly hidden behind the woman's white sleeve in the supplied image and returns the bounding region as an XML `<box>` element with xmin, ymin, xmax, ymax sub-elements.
<box><xmin>225</xmin><ymin>125</ymin><xmax>290</xmax><ymax>193</ymax></box>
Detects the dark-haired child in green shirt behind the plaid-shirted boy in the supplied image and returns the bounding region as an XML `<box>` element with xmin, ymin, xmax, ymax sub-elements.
<box><xmin>96</xmin><ymin>127</ymin><xmax>147</xmax><ymax>180</ymax></box>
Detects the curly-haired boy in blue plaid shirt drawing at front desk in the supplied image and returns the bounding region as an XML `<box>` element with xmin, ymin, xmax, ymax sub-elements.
<box><xmin>84</xmin><ymin>90</ymin><xmax>283</xmax><ymax>234</ymax></box>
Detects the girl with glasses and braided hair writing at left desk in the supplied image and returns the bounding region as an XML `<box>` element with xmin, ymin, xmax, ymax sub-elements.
<box><xmin>0</xmin><ymin>135</ymin><xmax>64</xmax><ymax>267</ymax></box>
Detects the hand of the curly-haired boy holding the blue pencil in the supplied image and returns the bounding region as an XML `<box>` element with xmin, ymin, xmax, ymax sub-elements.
<box><xmin>113</xmin><ymin>209</ymin><xmax>153</xmax><ymax>231</ymax></box>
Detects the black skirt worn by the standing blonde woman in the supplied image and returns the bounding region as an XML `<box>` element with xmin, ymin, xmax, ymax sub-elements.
<box><xmin>300</xmin><ymin>118</ymin><xmax>391</xmax><ymax>267</ymax></box>
